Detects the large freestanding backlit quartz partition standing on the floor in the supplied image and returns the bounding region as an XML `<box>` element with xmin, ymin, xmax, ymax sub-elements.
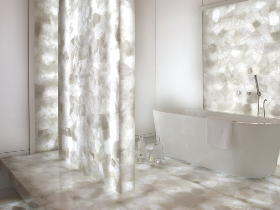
<box><xmin>58</xmin><ymin>0</ymin><xmax>135</xmax><ymax>193</ymax></box>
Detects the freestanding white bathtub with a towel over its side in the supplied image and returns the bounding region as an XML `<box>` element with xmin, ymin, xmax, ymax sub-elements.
<box><xmin>153</xmin><ymin>108</ymin><xmax>280</xmax><ymax>178</ymax></box>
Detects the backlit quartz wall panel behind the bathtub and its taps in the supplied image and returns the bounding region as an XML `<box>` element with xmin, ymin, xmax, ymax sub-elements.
<box><xmin>203</xmin><ymin>0</ymin><xmax>280</xmax><ymax>118</ymax></box>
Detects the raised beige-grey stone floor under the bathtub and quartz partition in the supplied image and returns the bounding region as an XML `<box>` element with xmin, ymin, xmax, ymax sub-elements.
<box><xmin>0</xmin><ymin>139</ymin><xmax>280</xmax><ymax>210</ymax></box>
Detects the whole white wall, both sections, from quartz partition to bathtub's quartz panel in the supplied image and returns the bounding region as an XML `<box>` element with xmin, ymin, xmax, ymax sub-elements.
<box><xmin>135</xmin><ymin>0</ymin><xmax>203</xmax><ymax>134</ymax></box>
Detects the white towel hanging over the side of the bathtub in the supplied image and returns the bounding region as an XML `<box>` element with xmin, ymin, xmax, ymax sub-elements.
<box><xmin>207</xmin><ymin>117</ymin><xmax>234</xmax><ymax>149</ymax></box>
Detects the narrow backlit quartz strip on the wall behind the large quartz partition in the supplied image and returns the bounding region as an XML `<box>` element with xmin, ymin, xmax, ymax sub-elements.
<box><xmin>35</xmin><ymin>0</ymin><xmax>59</xmax><ymax>152</ymax></box>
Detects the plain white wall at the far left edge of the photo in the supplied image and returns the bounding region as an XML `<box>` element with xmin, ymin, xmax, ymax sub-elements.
<box><xmin>0</xmin><ymin>0</ymin><xmax>29</xmax><ymax>157</ymax></box>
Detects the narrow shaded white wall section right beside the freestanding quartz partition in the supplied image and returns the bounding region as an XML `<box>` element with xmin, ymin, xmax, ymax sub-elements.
<box><xmin>135</xmin><ymin>0</ymin><xmax>156</xmax><ymax>135</ymax></box>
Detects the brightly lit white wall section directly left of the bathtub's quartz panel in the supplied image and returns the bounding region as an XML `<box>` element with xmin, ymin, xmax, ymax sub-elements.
<box><xmin>156</xmin><ymin>0</ymin><xmax>203</xmax><ymax>109</ymax></box>
